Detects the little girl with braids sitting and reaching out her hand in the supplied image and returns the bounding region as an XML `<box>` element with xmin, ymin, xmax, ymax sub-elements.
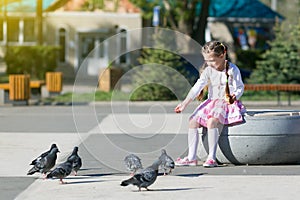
<box><xmin>175</xmin><ymin>41</ymin><xmax>246</xmax><ymax>167</ymax></box>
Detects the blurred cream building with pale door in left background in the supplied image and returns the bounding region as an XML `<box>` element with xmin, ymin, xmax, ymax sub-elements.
<box><xmin>0</xmin><ymin>0</ymin><xmax>142</xmax><ymax>80</ymax></box>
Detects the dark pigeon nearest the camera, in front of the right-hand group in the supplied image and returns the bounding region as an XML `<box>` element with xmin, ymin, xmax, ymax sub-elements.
<box><xmin>121</xmin><ymin>159</ymin><xmax>161</xmax><ymax>191</ymax></box>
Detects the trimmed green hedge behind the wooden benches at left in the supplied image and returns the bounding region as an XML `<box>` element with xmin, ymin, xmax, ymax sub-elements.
<box><xmin>4</xmin><ymin>46</ymin><xmax>59</xmax><ymax>79</ymax></box>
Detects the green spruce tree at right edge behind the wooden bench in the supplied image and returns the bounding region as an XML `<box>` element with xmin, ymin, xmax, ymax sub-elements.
<box><xmin>249</xmin><ymin>24</ymin><xmax>300</xmax><ymax>83</ymax></box>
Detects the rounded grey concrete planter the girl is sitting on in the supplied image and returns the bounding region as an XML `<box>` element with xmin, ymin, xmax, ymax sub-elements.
<box><xmin>202</xmin><ymin>110</ymin><xmax>300</xmax><ymax>165</ymax></box>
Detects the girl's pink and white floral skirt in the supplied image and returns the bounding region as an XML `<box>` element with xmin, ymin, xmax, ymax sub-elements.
<box><xmin>190</xmin><ymin>99</ymin><xmax>246</xmax><ymax>127</ymax></box>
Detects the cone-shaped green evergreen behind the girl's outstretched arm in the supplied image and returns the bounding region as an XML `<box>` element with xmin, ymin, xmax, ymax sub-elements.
<box><xmin>130</xmin><ymin>32</ymin><xmax>191</xmax><ymax>101</ymax></box>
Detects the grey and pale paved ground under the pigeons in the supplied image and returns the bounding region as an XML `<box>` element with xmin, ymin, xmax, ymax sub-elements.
<box><xmin>0</xmin><ymin>102</ymin><xmax>300</xmax><ymax>200</ymax></box>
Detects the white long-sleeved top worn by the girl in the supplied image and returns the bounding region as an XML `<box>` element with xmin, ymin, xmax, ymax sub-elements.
<box><xmin>188</xmin><ymin>62</ymin><xmax>244</xmax><ymax>100</ymax></box>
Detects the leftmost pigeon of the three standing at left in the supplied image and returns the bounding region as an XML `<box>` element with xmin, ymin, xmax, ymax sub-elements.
<box><xmin>27</xmin><ymin>148</ymin><xmax>59</xmax><ymax>175</ymax></box>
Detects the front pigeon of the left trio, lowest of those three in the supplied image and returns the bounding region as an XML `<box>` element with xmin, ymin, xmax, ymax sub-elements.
<box><xmin>46</xmin><ymin>157</ymin><xmax>76</xmax><ymax>184</ymax></box>
